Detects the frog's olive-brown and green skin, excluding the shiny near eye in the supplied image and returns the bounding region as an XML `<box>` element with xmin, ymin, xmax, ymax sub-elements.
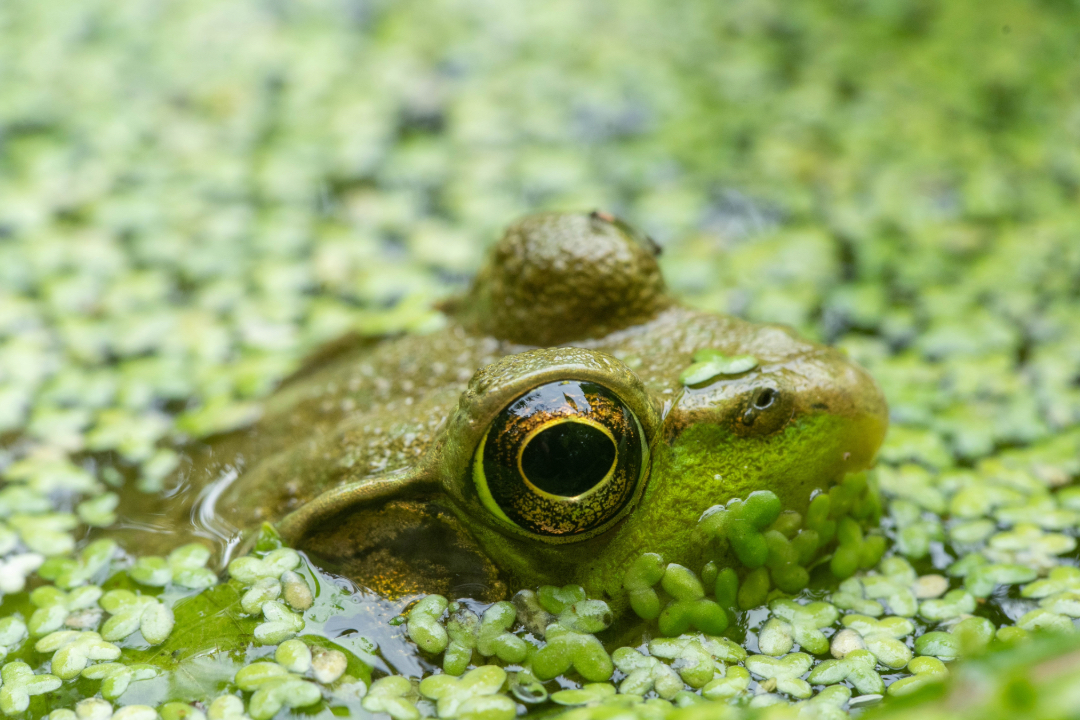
<box><xmin>204</xmin><ymin>214</ymin><xmax>887</xmax><ymax>598</ymax></box>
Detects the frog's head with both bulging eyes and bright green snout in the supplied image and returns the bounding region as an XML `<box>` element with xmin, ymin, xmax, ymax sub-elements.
<box><xmin>272</xmin><ymin>213</ymin><xmax>887</xmax><ymax>596</ymax></box>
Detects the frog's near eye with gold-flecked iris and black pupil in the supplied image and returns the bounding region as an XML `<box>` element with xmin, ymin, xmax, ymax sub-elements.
<box><xmin>473</xmin><ymin>380</ymin><xmax>647</xmax><ymax>538</ymax></box>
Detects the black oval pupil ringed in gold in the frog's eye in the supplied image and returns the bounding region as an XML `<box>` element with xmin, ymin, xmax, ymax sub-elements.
<box><xmin>522</xmin><ymin>421</ymin><xmax>616</xmax><ymax>498</ymax></box>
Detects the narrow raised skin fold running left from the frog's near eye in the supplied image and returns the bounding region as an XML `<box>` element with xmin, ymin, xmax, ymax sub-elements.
<box><xmin>276</xmin><ymin>464</ymin><xmax>438</xmax><ymax>545</ymax></box>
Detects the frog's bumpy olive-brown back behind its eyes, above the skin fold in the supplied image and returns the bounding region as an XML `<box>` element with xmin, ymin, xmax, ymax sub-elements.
<box><xmin>216</xmin><ymin>326</ymin><xmax>507</xmax><ymax>528</ymax></box>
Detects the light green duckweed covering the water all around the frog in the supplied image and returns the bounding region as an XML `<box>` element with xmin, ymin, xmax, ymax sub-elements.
<box><xmin>0</xmin><ymin>0</ymin><xmax>1080</xmax><ymax>720</ymax></box>
